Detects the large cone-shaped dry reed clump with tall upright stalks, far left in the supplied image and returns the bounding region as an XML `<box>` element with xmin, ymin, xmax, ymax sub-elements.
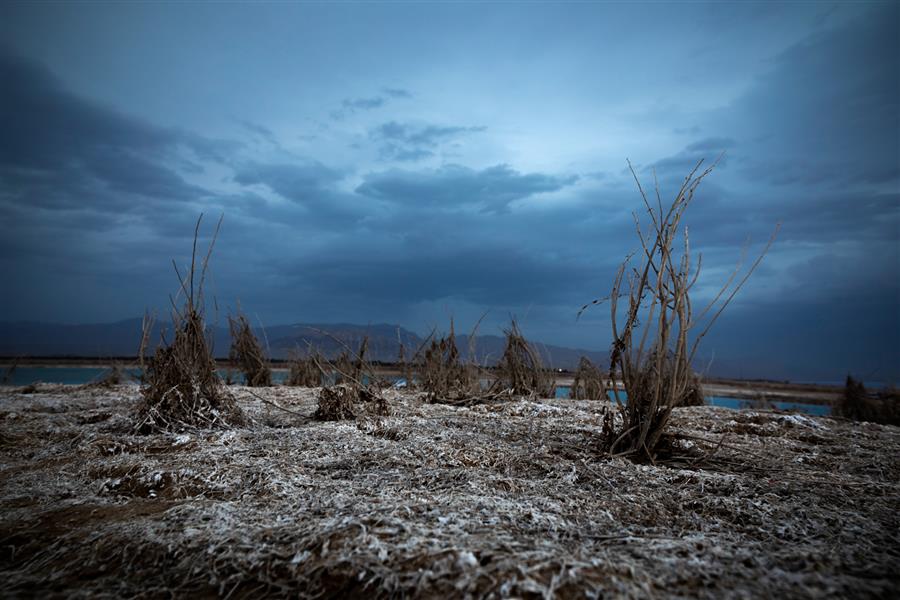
<box><xmin>135</xmin><ymin>215</ymin><xmax>245</xmax><ymax>432</ymax></box>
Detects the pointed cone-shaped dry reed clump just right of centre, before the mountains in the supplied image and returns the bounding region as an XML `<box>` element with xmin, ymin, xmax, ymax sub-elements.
<box><xmin>496</xmin><ymin>320</ymin><xmax>556</xmax><ymax>398</ymax></box>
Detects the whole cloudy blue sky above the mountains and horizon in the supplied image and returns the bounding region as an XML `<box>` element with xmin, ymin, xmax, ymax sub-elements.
<box><xmin>0</xmin><ymin>2</ymin><xmax>900</xmax><ymax>382</ymax></box>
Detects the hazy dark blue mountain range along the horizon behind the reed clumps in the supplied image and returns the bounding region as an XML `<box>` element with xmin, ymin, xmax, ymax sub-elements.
<box><xmin>0</xmin><ymin>319</ymin><xmax>608</xmax><ymax>369</ymax></box>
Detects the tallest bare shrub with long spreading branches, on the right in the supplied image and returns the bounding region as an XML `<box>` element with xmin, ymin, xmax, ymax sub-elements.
<box><xmin>579</xmin><ymin>161</ymin><xmax>778</xmax><ymax>461</ymax></box>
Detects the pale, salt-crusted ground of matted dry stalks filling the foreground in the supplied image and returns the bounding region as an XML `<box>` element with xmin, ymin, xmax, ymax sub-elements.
<box><xmin>0</xmin><ymin>385</ymin><xmax>900</xmax><ymax>598</ymax></box>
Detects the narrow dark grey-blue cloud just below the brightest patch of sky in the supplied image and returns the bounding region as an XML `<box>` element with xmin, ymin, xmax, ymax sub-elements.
<box><xmin>356</xmin><ymin>165</ymin><xmax>578</xmax><ymax>212</ymax></box>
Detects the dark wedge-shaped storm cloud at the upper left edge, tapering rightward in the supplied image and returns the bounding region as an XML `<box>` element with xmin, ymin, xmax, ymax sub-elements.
<box><xmin>0</xmin><ymin>54</ymin><xmax>230</xmax><ymax>211</ymax></box>
